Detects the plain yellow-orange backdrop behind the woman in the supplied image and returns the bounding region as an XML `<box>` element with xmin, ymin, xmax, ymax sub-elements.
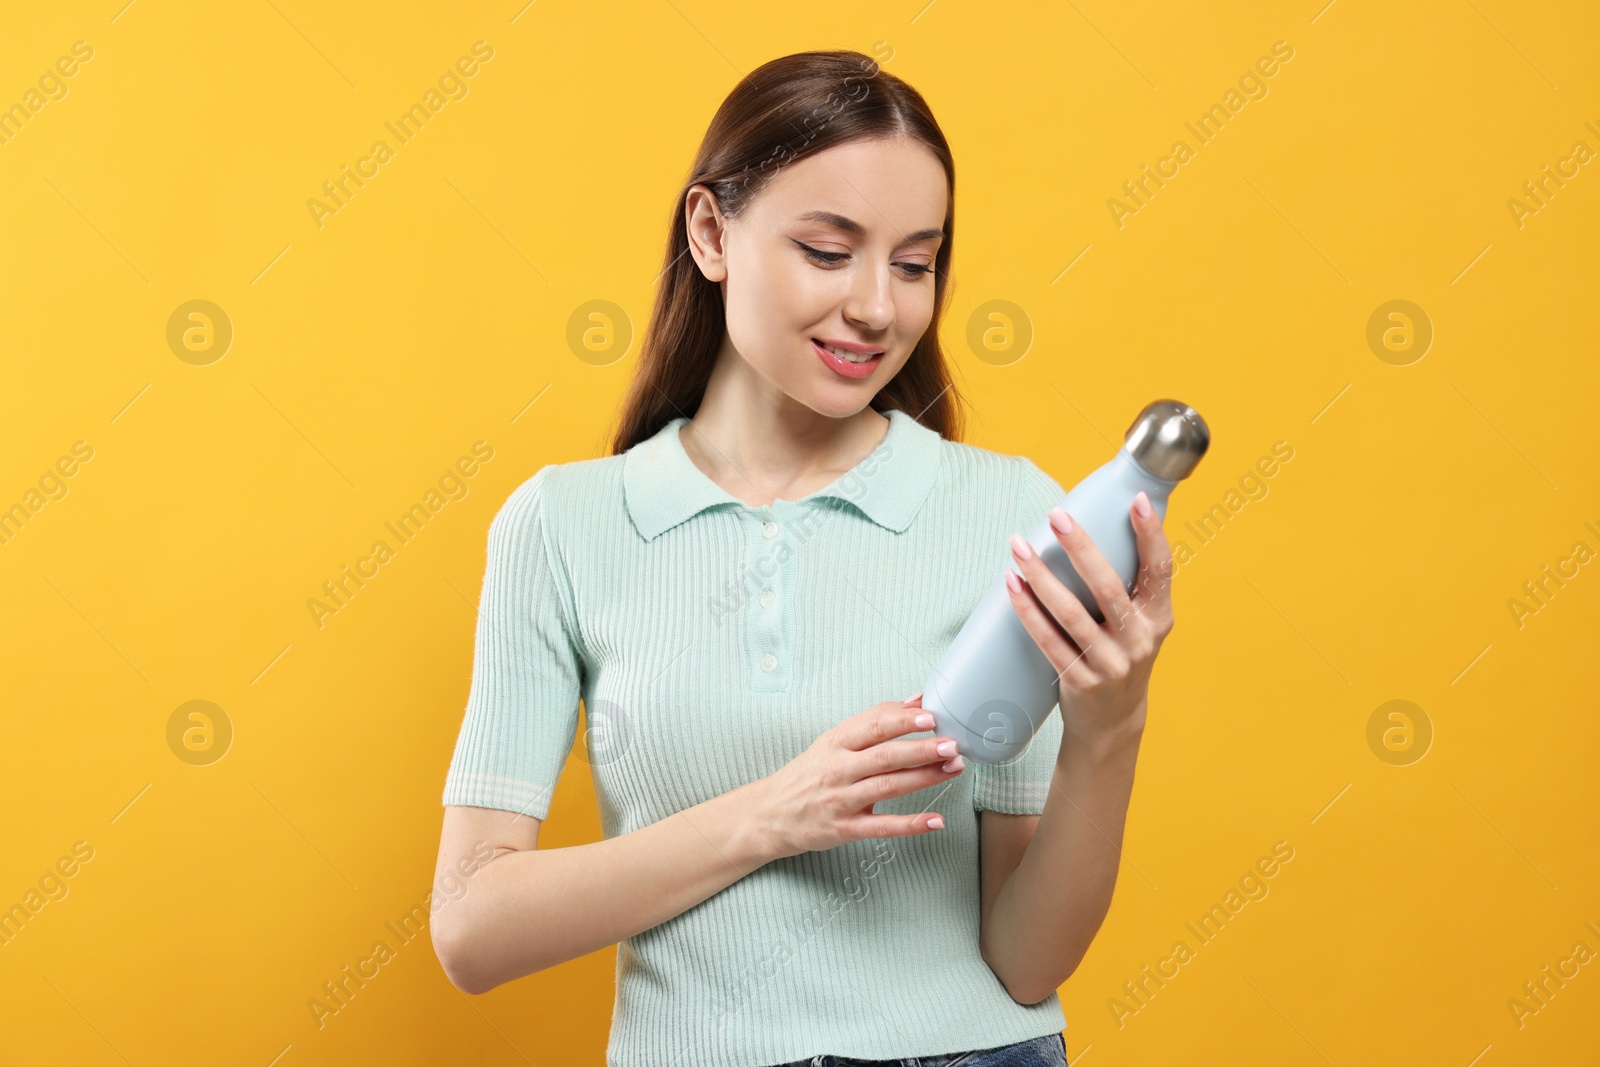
<box><xmin>0</xmin><ymin>0</ymin><xmax>1600</xmax><ymax>1067</ymax></box>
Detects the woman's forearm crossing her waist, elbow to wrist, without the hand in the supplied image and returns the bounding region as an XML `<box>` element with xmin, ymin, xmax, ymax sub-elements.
<box><xmin>434</xmin><ymin>782</ymin><xmax>771</xmax><ymax>993</ymax></box>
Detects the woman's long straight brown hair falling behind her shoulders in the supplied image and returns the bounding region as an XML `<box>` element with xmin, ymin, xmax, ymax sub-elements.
<box><xmin>611</xmin><ymin>51</ymin><xmax>963</xmax><ymax>454</ymax></box>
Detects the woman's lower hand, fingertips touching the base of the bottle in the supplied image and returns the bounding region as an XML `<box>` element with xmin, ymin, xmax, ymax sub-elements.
<box><xmin>752</xmin><ymin>693</ymin><xmax>963</xmax><ymax>859</ymax></box>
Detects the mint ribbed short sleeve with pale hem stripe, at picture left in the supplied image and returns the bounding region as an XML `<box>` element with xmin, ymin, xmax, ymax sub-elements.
<box><xmin>443</xmin><ymin>467</ymin><xmax>582</xmax><ymax>819</ymax></box>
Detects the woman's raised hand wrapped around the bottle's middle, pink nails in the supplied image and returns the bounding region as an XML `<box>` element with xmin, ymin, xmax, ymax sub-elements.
<box><xmin>1006</xmin><ymin>493</ymin><xmax>1173</xmax><ymax>744</ymax></box>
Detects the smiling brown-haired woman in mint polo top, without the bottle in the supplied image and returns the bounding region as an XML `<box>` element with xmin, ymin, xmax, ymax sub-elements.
<box><xmin>432</xmin><ymin>51</ymin><xmax>1173</xmax><ymax>1067</ymax></box>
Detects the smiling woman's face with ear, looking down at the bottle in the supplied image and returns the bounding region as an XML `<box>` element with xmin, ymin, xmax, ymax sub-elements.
<box><xmin>686</xmin><ymin>138</ymin><xmax>949</xmax><ymax>418</ymax></box>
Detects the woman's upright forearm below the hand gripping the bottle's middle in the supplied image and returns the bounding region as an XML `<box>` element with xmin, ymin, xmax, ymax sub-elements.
<box><xmin>982</xmin><ymin>713</ymin><xmax>1142</xmax><ymax>1005</ymax></box>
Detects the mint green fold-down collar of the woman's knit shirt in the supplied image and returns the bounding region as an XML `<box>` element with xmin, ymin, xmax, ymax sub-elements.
<box><xmin>622</xmin><ymin>408</ymin><xmax>942</xmax><ymax>541</ymax></box>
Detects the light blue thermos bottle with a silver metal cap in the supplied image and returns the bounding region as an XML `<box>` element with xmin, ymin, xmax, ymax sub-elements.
<box><xmin>922</xmin><ymin>400</ymin><xmax>1211</xmax><ymax>765</ymax></box>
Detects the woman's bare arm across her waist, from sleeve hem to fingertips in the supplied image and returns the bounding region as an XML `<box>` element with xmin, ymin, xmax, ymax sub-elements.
<box><xmin>430</xmin><ymin>694</ymin><xmax>962</xmax><ymax>993</ymax></box>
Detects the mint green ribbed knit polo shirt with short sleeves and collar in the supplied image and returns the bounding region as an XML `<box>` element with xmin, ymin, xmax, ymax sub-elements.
<box><xmin>443</xmin><ymin>410</ymin><xmax>1066</xmax><ymax>1067</ymax></box>
